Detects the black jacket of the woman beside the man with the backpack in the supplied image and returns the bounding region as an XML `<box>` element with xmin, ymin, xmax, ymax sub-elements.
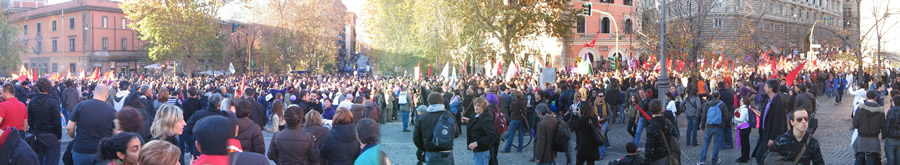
<box><xmin>466</xmin><ymin>112</ymin><xmax>500</xmax><ymax>152</ymax></box>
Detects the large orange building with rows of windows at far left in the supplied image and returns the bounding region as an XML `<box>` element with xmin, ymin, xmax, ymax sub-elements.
<box><xmin>11</xmin><ymin>0</ymin><xmax>147</xmax><ymax>73</ymax></box>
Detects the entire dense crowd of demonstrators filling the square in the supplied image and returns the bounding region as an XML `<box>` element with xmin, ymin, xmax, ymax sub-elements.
<box><xmin>0</xmin><ymin>60</ymin><xmax>900</xmax><ymax>164</ymax></box>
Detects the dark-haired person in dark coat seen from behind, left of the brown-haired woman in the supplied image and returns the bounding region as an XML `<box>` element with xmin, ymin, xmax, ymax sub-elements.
<box><xmin>268</xmin><ymin>105</ymin><xmax>322</xmax><ymax>164</ymax></box>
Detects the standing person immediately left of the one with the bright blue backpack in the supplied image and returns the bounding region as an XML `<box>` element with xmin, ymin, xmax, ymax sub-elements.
<box><xmin>681</xmin><ymin>88</ymin><xmax>703</xmax><ymax>146</ymax></box>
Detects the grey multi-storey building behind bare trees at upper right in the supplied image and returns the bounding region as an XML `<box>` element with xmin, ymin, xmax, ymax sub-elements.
<box><xmin>666</xmin><ymin>0</ymin><xmax>844</xmax><ymax>58</ymax></box>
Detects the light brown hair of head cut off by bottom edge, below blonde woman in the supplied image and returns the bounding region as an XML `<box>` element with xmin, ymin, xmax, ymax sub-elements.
<box><xmin>138</xmin><ymin>140</ymin><xmax>181</xmax><ymax>165</ymax></box>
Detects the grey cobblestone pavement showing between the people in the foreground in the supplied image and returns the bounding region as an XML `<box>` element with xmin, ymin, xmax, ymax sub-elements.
<box><xmin>381</xmin><ymin>96</ymin><xmax>854</xmax><ymax>165</ymax></box>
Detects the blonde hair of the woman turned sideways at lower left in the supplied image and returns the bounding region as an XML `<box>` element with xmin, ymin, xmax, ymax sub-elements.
<box><xmin>150</xmin><ymin>104</ymin><xmax>184</xmax><ymax>138</ymax></box>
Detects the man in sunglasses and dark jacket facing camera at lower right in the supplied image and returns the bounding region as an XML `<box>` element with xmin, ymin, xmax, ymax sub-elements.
<box><xmin>769</xmin><ymin>108</ymin><xmax>824</xmax><ymax>165</ymax></box>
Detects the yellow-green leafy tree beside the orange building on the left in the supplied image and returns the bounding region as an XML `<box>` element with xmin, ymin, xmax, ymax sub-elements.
<box><xmin>119</xmin><ymin>0</ymin><xmax>224</xmax><ymax>72</ymax></box>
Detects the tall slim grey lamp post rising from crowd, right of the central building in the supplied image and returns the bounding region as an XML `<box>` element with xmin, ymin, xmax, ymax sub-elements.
<box><xmin>656</xmin><ymin>0</ymin><xmax>669</xmax><ymax>102</ymax></box>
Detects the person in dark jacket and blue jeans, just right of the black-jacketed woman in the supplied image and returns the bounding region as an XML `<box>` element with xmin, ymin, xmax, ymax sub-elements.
<box><xmin>502</xmin><ymin>91</ymin><xmax>528</xmax><ymax>152</ymax></box>
